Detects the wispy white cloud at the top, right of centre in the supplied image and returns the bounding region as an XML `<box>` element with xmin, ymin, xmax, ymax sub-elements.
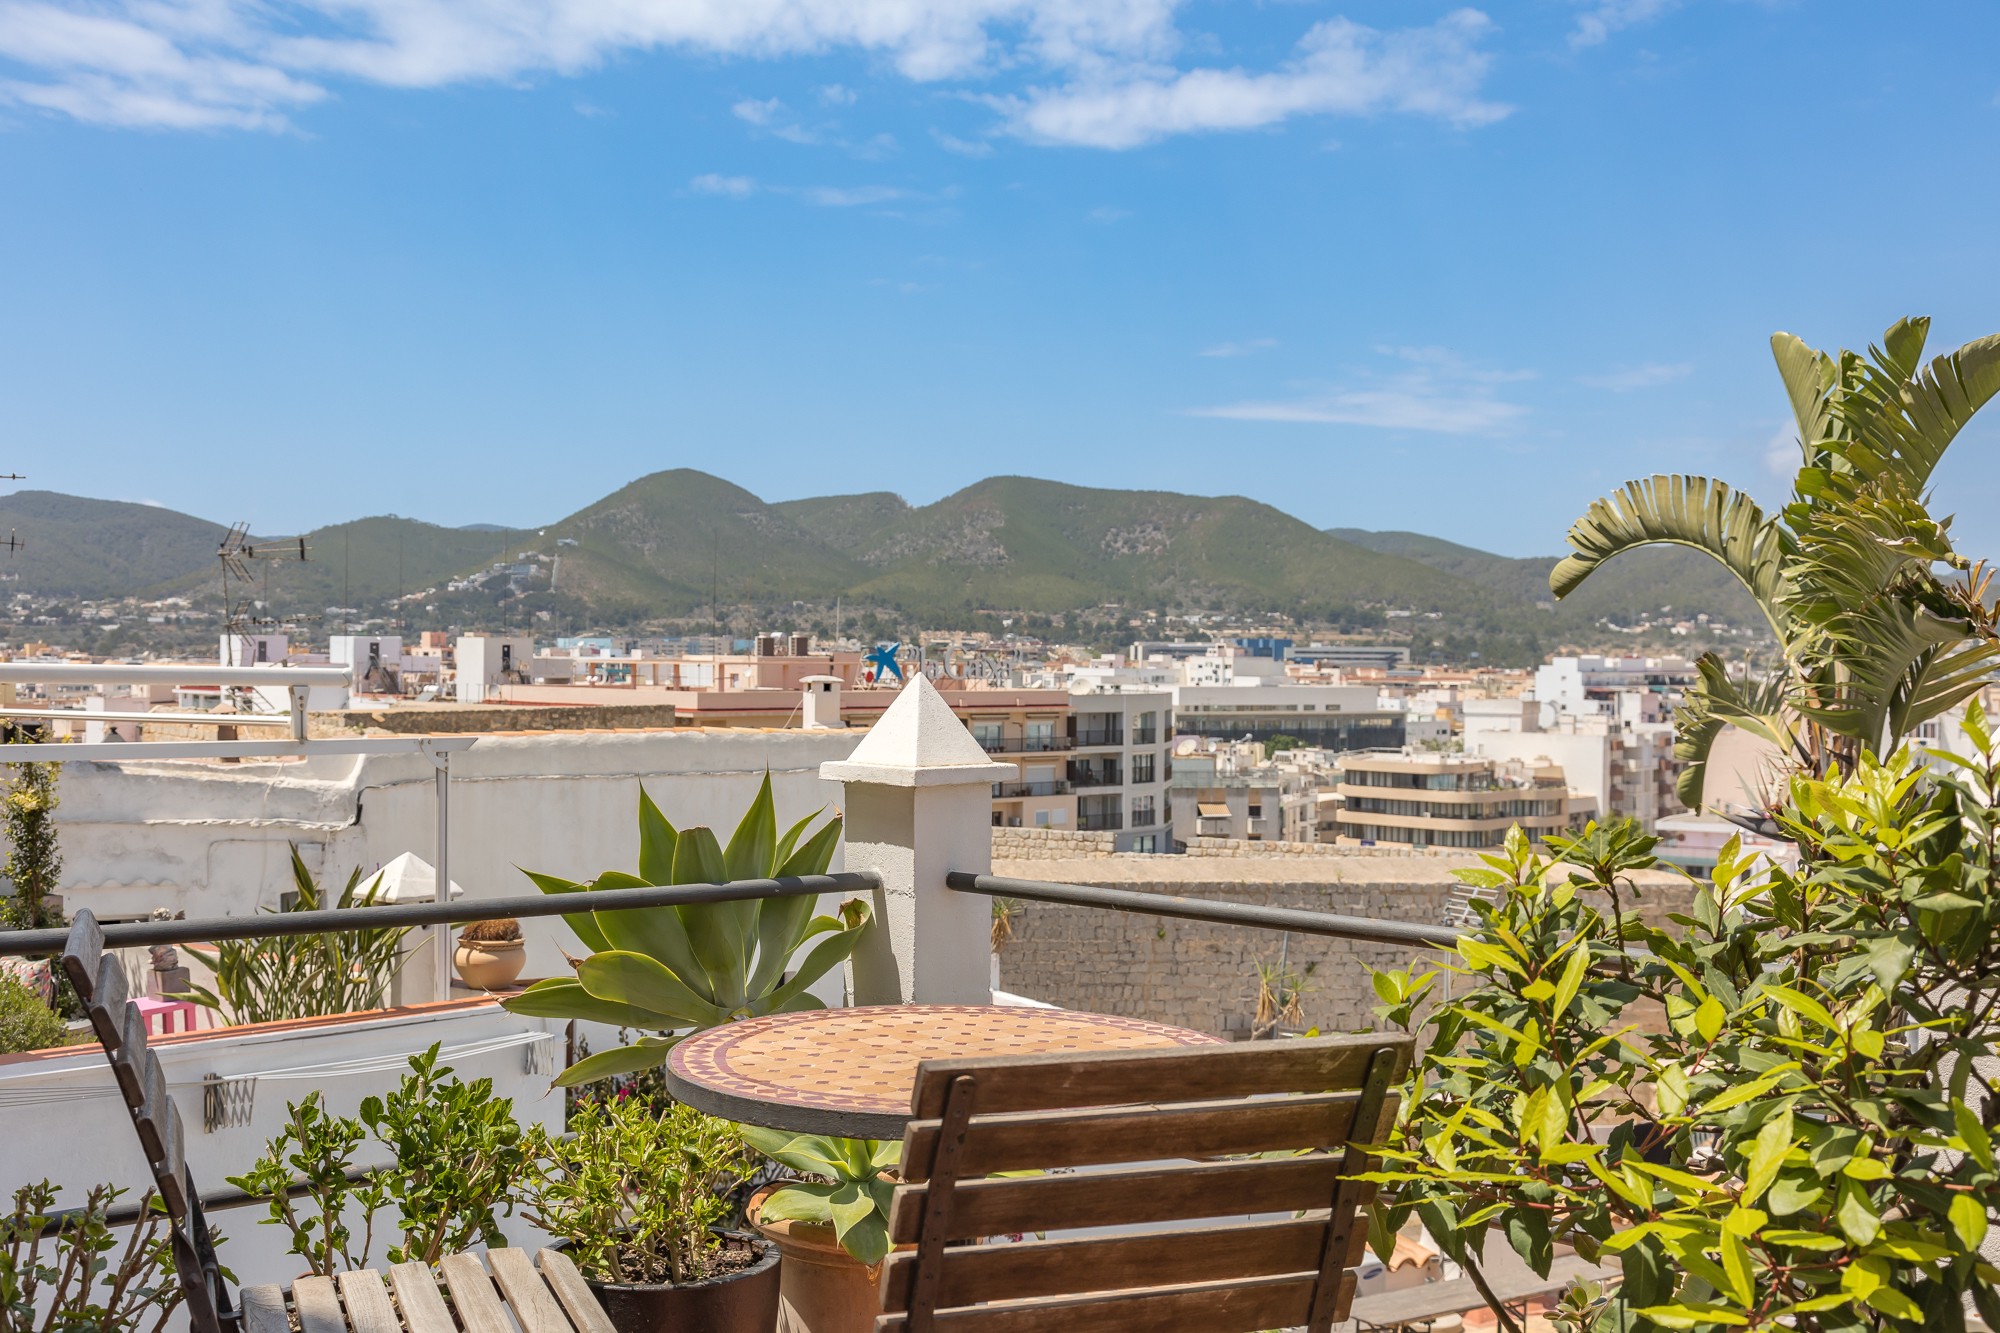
<box><xmin>990</xmin><ymin>10</ymin><xmax>1510</xmax><ymax>148</ymax></box>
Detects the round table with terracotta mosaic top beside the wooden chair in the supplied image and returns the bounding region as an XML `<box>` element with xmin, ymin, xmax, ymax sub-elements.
<box><xmin>666</xmin><ymin>1005</ymin><xmax>1216</xmax><ymax>1139</ymax></box>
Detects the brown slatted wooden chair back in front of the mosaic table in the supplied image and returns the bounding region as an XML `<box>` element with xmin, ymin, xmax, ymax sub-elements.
<box><xmin>876</xmin><ymin>1035</ymin><xmax>1414</xmax><ymax>1333</ymax></box>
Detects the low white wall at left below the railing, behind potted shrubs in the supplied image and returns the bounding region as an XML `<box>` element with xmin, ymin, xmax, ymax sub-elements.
<box><xmin>0</xmin><ymin>1001</ymin><xmax>564</xmax><ymax>1283</ymax></box>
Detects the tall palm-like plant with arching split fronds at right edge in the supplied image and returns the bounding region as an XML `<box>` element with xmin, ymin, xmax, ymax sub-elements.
<box><xmin>1548</xmin><ymin>318</ymin><xmax>2000</xmax><ymax>807</ymax></box>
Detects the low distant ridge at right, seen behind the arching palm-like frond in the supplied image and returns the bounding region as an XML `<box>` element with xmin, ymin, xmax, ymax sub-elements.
<box><xmin>1328</xmin><ymin>528</ymin><xmax>1762</xmax><ymax>624</ymax></box>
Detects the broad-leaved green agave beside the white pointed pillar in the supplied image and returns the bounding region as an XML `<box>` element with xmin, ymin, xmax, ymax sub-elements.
<box><xmin>502</xmin><ymin>775</ymin><xmax>868</xmax><ymax>1087</ymax></box>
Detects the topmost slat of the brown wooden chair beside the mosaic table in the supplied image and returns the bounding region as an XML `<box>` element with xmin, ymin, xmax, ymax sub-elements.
<box><xmin>910</xmin><ymin>1035</ymin><xmax>1410</xmax><ymax>1121</ymax></box>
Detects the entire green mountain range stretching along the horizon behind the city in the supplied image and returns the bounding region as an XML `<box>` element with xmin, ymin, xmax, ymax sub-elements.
<box><xmin>0</xmin><ymin>468</ymin><xmax>1754</xmax><ymax>640</ymax></box>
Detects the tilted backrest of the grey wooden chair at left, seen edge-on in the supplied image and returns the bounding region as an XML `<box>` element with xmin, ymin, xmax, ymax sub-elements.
<box><xmin>62</xmin><ymin>911</ymin><xmax>234</xmax><ymax>1333</ymax></box>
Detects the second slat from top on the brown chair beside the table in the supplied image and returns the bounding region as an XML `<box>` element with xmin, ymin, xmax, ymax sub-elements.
<box><xmin>902</xmin><ymin>1093</ymin><xmax>1360</xmax><ymax>1183</ymax></box>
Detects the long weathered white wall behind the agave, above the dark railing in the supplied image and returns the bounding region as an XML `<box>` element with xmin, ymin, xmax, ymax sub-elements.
<box><xmin>47</xmin><ymin>729</ymin><xmax>862</xmax><ymax>977</ymax></box>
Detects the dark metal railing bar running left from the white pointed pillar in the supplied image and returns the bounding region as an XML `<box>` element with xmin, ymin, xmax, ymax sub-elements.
<box><xmin>0</xmin><ymin>871</ymin><xmax>882</xmax><ymax>959</ymax></box>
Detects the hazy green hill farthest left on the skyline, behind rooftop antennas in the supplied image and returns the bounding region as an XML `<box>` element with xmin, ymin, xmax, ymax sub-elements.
<box><xmin>0</xmin><ymin>490</ymin><xmax>226</xmax><ymax>598</ymax></box>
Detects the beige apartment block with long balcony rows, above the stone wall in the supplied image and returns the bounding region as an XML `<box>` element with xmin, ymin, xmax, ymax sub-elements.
<box><xmin>1338</xmin><ymin>751</ymin><xmax>1598</xmax><ymax>849</ymax></box>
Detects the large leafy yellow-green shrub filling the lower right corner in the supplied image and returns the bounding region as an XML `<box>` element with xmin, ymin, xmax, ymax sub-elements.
<box><xmin>1374</xmin><ymin>707</ymin><xmax>2000</xmax><ymax>1333</ymax></box>
